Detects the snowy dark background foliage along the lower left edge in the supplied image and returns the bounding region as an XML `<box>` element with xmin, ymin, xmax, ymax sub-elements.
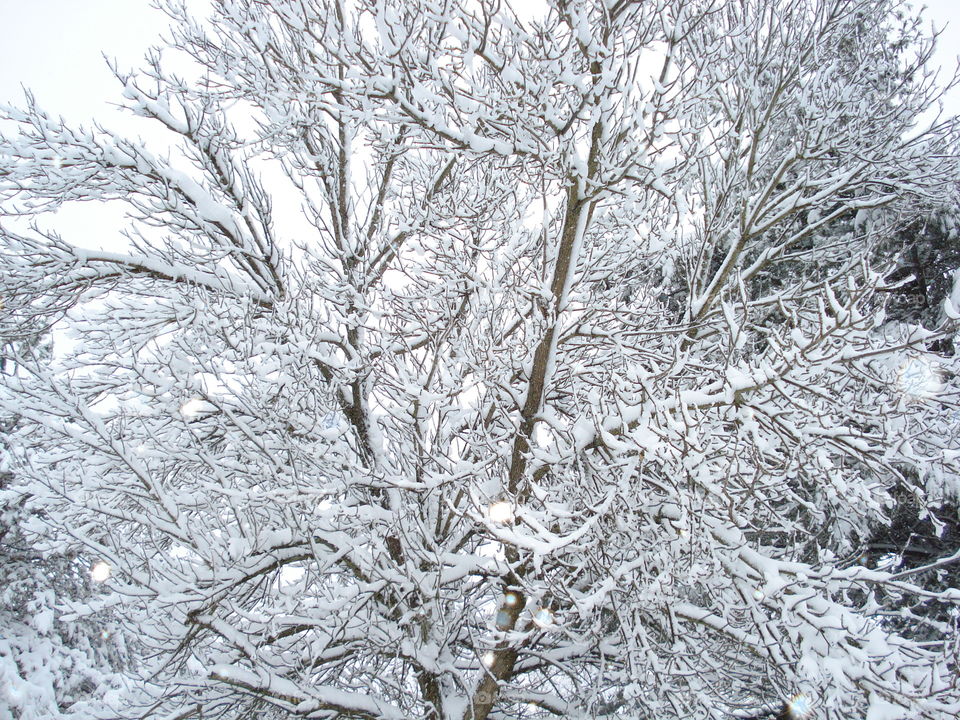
<box><xmin>0</xmin><ymin>334</ymin><xmax>127</xmax><ymax>720</ymax></box>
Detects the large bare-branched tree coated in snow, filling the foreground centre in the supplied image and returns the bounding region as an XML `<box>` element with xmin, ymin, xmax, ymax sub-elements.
<box><xmin>0</xmin><ymin>0</ymin><xmax>960</xmax><ymax>720</ymax></box>
